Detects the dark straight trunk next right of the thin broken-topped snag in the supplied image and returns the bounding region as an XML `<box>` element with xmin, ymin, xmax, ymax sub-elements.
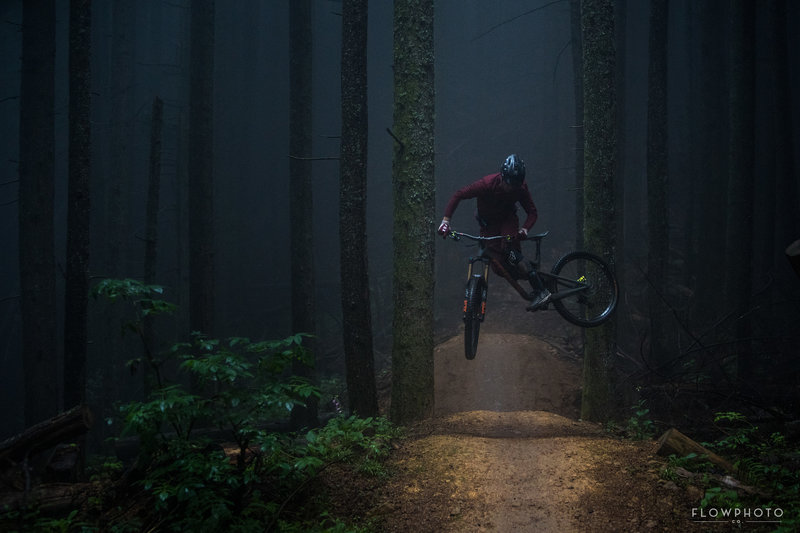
<box><xmin>189</xmin><ymin>0</ymin><xmax>214</xmax><ymax>334</ymax></box>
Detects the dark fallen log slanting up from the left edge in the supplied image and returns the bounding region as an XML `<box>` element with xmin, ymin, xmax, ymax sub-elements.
<box><xmin>0</xmin><ymin>405</ymin><xmax>92</xmax><ymax>465</ymax></box>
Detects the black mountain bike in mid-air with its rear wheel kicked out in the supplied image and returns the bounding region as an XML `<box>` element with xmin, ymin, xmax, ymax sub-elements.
<box><xmin>448</xmin><ymin>230</ymin><xmax>619</xmax><ymax>359</ymax></box>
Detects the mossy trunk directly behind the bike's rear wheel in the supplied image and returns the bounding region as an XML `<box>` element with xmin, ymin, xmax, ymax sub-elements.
<box><xmin>581</xmin><ymin>0</ymin><xmax>617</xmax><ymax>421</ymax></box>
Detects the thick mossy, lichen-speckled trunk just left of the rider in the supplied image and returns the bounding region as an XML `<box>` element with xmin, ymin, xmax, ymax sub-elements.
<box><xmin>391</xmin><ymin>0</ymin><xmax>435</xmax><ymax>424</ymax></box>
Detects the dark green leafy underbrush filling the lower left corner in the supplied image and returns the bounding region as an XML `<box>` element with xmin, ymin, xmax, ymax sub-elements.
<box><xmin>0</xmin><ymin>280</ymin><xmax>400</xmax><ymax>533</ymax></box>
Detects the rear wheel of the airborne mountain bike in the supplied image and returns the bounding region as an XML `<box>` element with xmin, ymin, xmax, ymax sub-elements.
<box><xmin>550</xmin><ymin>252</ymin><xmax>619</xmax><ymax>328</ymax></box>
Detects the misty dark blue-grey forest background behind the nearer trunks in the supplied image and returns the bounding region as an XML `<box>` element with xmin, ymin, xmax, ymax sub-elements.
<box><xmin>0</xmin><ymin>0</ymin><xmax>800</xmax><ymax>438</ymax></box>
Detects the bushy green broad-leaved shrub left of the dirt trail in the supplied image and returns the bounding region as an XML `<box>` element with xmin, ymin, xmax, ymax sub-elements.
<box><xmin>110</xmin><ymin>334</ymin><xmax>397</xmax><ymax>531</ymax></box>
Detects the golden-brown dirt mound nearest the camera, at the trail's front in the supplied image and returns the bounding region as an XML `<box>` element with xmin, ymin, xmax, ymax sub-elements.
<box><xmin>367</xmin><ymin>411</ymin><xmax>694</xmax><ymax>533</ymax></box>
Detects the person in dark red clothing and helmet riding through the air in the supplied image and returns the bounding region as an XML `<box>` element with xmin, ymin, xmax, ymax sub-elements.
<box><xmin>438</xmin><ymin>154</ymin><xmax>551</xmax><ymax>311</ymax></box>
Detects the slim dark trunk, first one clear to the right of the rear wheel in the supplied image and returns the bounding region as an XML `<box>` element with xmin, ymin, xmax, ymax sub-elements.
<box><xmin>647</xmin><ymin>0</ymin><xmax>677</xmax><ymax>364</ymax></box>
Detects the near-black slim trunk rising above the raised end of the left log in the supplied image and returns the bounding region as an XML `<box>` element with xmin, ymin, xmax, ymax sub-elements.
<box><xmin>64</xmin><ymin>0</ymin><xmax>92</xmax><ymax>405</ymax></box>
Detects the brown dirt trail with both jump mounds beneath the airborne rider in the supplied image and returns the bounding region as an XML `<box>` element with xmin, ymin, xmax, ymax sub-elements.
<box><xmin>327</xmin><ymin>288</ymin><xmax>759</xmax><ymax>533</ymax></box>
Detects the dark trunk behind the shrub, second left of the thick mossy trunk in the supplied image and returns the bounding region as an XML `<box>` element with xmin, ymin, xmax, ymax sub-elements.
<box><xmin>289</xmin><ymin>0</ymin><xmax>317</xmax><ymax>428</ymax></box>
